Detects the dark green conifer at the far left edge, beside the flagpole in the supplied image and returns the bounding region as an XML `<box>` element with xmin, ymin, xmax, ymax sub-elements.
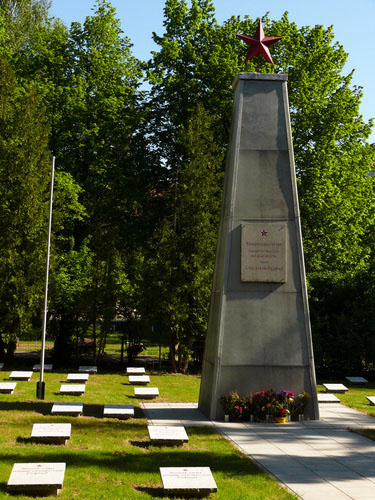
<box><xmin>0</xmin><ymin>55</ymin><xmax>51</xmax><ymax>360</ymax></box>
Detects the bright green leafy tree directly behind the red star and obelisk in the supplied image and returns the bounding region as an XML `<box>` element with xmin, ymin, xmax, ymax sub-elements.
<box><xmin>148</xmin><ymin>0</ymin><xmax>375</xmax><ymax>374</ymax></box>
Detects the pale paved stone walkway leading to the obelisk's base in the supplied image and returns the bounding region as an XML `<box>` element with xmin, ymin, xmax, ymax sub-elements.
<box><xmin>143</xmin><ymin>403</ymin><xmax>375</xmax><ymax>500</ymax></box>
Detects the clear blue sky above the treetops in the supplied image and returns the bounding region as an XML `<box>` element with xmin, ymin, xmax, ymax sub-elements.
<box><xmin>50</xmin><ymin>0</ymin><xmax>375</xmax><ymax>142</ymax></box>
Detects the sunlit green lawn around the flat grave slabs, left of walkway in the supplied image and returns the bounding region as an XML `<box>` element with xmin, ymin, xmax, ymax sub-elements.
<box><xmin>0</xmin><ymin>372</ymin><xmax>296</xmax><ymax>500</ymax></box>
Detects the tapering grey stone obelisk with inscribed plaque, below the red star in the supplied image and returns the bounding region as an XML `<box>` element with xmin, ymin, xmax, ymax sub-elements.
<box><xmin>199</xmin><ymin>73</ymin><xmax>319</xmax><ymax>419</ymax></box>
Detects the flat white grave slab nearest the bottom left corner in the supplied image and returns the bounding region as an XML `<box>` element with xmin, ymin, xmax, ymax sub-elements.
<box><xmin>8</xmin><ymin>462</ymin><xmax>66</xmax><ymax>495</ymax></box>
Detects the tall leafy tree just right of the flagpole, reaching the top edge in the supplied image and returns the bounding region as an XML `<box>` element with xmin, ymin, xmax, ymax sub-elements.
<box><xmin>18</xmin><ymin>0</ymin><xmax>141</xmax><ymax>358</ymax></box>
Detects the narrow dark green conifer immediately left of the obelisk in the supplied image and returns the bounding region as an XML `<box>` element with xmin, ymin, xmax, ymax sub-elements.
<box><xmin>140</xmin><ymin>106</ymin><xmax>224</xmax><ymax>373</ymax></box>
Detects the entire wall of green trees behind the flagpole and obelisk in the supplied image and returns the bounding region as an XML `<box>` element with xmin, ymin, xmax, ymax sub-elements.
<box><xmin>0</xmin><ymin>0</ymin><xmax>375</xmax><ymax>371</ymax></box>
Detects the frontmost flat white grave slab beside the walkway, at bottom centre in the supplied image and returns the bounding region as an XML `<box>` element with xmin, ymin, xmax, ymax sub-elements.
<box><xmin>160</xmin><ymin>467</ymin><xmax>217</xmax><ymax>495</ymax></box>
